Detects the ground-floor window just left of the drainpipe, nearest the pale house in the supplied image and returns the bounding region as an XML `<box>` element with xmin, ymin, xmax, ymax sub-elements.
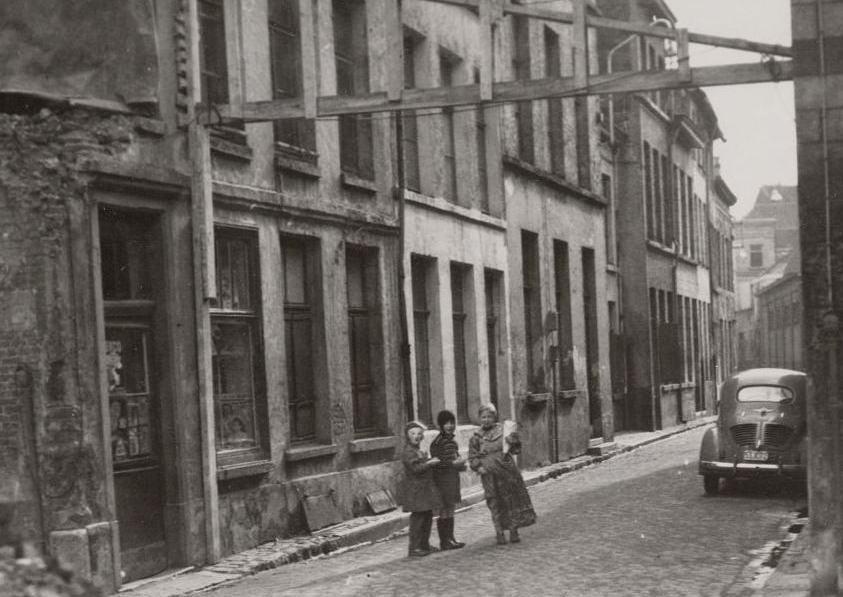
<box><xmin>345</xmin><ymin>245</ymin><xmax>383</xmax><ymax>434</ymax></box>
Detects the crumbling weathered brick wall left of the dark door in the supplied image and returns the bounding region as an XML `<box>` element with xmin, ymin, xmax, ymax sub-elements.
<box><xmin>0</xmin><ymin>109</ymin><xmax>138</xmax><ymax>588</ymax></box>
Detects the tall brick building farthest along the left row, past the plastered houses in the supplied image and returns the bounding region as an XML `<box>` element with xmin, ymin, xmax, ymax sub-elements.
<box><xmin>598</xmin><ymin>0</ymin><xmax>725</xmax><ymax>429</ymax></box>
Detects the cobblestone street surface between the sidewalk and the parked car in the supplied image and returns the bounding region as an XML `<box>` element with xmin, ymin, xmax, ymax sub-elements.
<box><xmin>203</xmin><ymin>429</ymin><xmax>805</xmax><ymax>597</ymax></box>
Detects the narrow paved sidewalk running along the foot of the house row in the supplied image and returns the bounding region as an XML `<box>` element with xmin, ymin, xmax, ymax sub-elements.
<box><xmin>120</xmin><ymin>417</ymin><xmax>724</xmax><ymax>597</ymax></box>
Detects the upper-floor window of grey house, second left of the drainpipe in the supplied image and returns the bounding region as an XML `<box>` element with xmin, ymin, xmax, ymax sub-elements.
<box><xmin>268</xmin><ymin>0</ymin><xmax>316</xmax><ymax>159</ymax></box>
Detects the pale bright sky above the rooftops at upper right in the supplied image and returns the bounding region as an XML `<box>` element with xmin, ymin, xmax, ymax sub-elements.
<box><xmin>666</xmin><ymin>0</ymin><xmax>796</xmax><ymax>219</ymax></box>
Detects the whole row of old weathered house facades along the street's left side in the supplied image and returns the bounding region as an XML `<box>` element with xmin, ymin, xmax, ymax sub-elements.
<box><xmin>0</xmin><ymin>0</ymin><xmax>744</xmax><ymax>589</ymax></box>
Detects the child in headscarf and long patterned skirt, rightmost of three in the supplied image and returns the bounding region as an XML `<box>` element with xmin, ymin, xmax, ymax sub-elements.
<box><xmin>468</xmin><ymin>404</ymin><xmax>536</xmax><ymax>545</ymax></box>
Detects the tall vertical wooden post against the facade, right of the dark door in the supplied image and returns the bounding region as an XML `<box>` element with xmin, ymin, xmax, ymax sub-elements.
<box><xmin>188</xmin><ymin>0</ymin><xmax>220</xmax><ymax>563</ymax></box>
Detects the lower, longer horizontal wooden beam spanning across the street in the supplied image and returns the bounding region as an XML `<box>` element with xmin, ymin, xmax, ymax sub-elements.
<box><xmin>208</xmin><ymin>60</ymin><xmax>793</xmax><ymax>122</ymax></box>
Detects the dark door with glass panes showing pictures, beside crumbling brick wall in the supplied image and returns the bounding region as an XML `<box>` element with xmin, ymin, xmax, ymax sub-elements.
<box><xmin>99</xmin><ymin>207</ymin><xmax>167</xmax><ymax>582</ymax></box>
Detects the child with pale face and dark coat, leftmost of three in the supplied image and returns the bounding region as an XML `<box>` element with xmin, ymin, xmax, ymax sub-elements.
<box><xmin>401</xmin><ymin>421</ymin><xmax>442</xmax><ymax>557</ymax></box>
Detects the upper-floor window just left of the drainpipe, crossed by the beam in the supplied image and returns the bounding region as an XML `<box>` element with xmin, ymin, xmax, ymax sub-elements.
<box><xmin>333</xmin><ymin>0</ymin><xmax>375</xmax><ymax>180</ymax></box>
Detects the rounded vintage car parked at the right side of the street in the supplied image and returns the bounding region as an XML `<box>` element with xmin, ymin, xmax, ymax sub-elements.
<box><xmin>699</xmin><ymin>369</ymin><xmax>807</xmax><ymax>495</ymax></box>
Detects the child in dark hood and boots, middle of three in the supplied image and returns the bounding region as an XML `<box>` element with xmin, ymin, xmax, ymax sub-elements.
<box><xmin>430</xmin><ymin>410</ymin><xmax>466</xmax><ymax>549</ymax></box>
